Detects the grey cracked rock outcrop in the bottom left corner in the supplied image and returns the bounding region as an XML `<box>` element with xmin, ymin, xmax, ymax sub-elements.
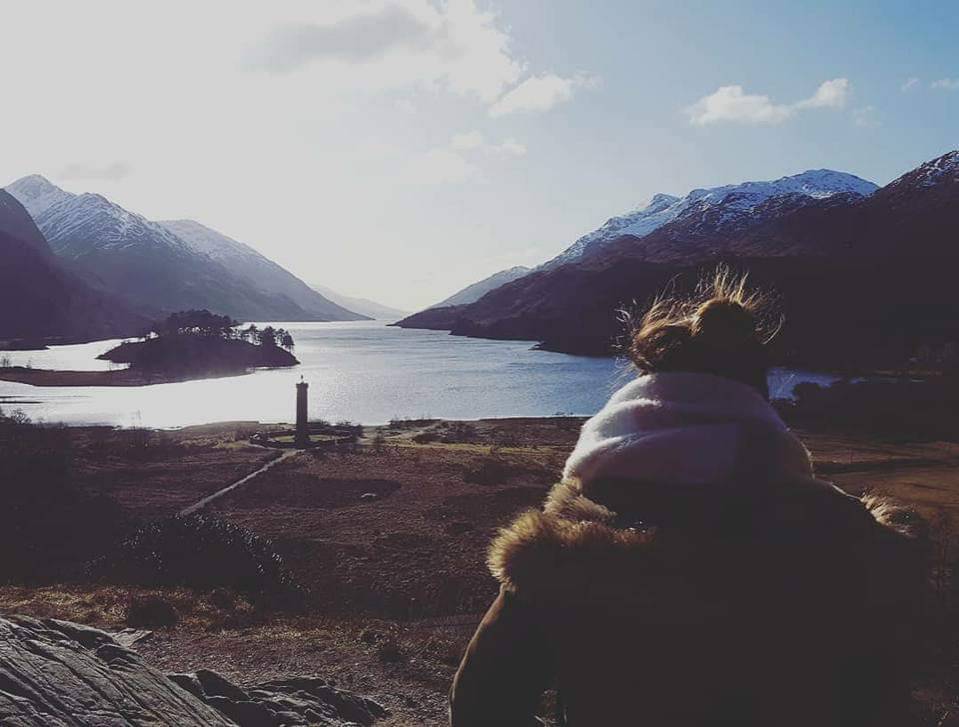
<box><xmin>0</xmin><ymin>616</ymin><xmax>387</xmax><ymax>727</ymax></box>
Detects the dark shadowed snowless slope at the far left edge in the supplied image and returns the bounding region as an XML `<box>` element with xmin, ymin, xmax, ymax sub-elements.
<box><xmin>0</xmin><ymin>190</ymin><xmax>147</xmax><ymax>341</ymax></box>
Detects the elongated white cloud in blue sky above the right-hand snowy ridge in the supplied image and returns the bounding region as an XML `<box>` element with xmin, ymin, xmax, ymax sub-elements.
<box><xmin>686</xmin><ymin>78</ymin><xmax>849</xmax><ymax>126</ymax></box>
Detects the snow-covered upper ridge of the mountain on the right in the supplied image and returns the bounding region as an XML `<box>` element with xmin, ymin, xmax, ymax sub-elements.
<box><xmin>541</xmin><ymin>169</ymin><xmax>878</xmax><ymax>269</ymax></box>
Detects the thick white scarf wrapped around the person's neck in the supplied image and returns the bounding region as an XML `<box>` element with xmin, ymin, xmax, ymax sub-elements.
<box><xmin>563</xmin><ymin>373</ymin><xmax>825</xmax><ymax>491</ymax></box>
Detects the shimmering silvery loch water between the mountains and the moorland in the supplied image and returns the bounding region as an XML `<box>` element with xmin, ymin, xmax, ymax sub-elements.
<box><xmin>0</xmin><ymin>321</ymin><xmax>834</xmax><ymax>428</ymax></box>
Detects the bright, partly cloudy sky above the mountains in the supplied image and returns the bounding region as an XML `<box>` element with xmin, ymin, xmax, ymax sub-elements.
<box><xmin>0</xmin><ymin>0</ymin><xmax>959</xmax><ymax>310</ymax></box>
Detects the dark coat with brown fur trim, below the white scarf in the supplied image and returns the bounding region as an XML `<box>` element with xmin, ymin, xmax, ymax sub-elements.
<box><xmin>450</xmin><ymin>480</ymin><xmax>922</xmax><ymax>727</ymax></box>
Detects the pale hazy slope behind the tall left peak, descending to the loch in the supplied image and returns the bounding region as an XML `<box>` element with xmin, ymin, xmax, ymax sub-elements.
<box><xmin>159</xmin><ymin>220</ymin><xmax>367</xmax><ymax>321</ymax></box>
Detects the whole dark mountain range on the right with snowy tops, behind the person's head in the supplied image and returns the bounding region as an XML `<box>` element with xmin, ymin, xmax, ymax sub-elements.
<box><xmin>398</xmin><ymin>151</ymin><xmax>959</xmax><ymax>366</ymax></box>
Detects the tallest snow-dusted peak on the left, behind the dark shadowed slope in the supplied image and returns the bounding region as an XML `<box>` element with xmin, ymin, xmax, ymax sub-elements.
<box><xmin>8</xmin><ymin>175</ymin><xmax>364</xmax><ymax>320</ymax></box>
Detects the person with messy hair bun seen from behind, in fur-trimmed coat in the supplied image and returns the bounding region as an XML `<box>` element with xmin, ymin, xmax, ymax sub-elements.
<box><xmin>450</xmin><ymin>270</ymin><xmax>923</xmax><ymax>727</ymax></box>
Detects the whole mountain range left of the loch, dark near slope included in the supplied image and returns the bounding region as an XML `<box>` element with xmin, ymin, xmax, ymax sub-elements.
<box><xmin>0</xmin><ymin>175</ymin><xmax>432</xmax><ymax>343</ymax></box>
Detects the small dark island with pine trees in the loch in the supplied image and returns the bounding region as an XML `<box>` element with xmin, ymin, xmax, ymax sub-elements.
<box><xmin>0</xmin><ymin>310</ymin><xmax>299</xmax><ymax>386</ymax></box>
